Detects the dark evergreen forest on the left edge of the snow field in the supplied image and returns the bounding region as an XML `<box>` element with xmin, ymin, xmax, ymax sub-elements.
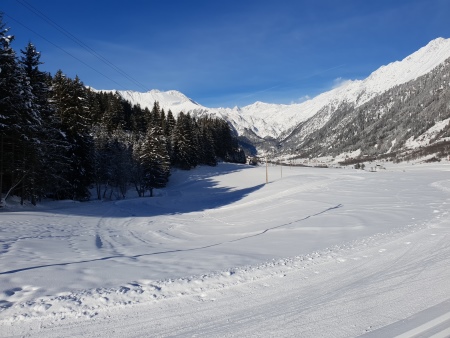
<box><xmin>0</xmin><ymin>13</ymin><xmax>245</xmax><ymax>205</ymax></box>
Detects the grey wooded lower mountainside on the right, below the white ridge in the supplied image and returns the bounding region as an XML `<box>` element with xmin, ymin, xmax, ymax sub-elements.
<box><xmin>279</xmin><ymin>59</ymin><xmax>450</xmax><ymax>160</ymax></box>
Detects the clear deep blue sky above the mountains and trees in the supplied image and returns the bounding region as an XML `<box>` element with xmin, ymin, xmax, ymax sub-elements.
<box><xmin>0</xmin><ymin>0</ymin><xmax>450</xmax><ymax>107</ymax></box>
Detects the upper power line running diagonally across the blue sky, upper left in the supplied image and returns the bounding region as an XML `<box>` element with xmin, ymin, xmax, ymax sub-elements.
<box><xmin>16</xmin><ymin>0</ymin><xmax>148</xmax><ymax>91</ymax></box>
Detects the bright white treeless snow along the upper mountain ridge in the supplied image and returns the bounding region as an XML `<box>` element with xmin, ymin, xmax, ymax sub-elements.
<box><xmin>103</xmin><ymin>38</ymin><xmax>450</xmax><ymax>138</ymax></box>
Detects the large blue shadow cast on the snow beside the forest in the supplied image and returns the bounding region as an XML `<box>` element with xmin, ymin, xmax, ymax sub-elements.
<box><xmin>5</xmin><ymin>163</ymin><xmax>264</xmax><ymax>217</ymax></box>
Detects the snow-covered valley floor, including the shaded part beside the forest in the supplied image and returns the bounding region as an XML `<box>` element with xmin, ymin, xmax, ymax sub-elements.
<box><xmin>0</xmin><ymin>163</ymin><xmax>450</xmax><ymax>338</ymax></box>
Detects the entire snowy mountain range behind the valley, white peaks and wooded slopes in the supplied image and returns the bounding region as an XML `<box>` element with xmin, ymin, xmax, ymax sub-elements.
<box><xmin>103</xmin><ymin>38</ymin><xmax>450</xmax><ymax>161</ymax></box>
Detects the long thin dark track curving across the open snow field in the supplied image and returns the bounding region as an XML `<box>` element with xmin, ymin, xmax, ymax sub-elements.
<box><xmin>0</xmin><ymin>204</ymin><xmax>342</xmax><ymax>275</ymax></box>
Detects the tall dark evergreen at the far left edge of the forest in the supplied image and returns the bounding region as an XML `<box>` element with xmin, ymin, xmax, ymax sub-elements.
<box><xmin>0</xmin><ymin>16</ymin><xmax>41</xmax><ymax>204</ymax></box>
